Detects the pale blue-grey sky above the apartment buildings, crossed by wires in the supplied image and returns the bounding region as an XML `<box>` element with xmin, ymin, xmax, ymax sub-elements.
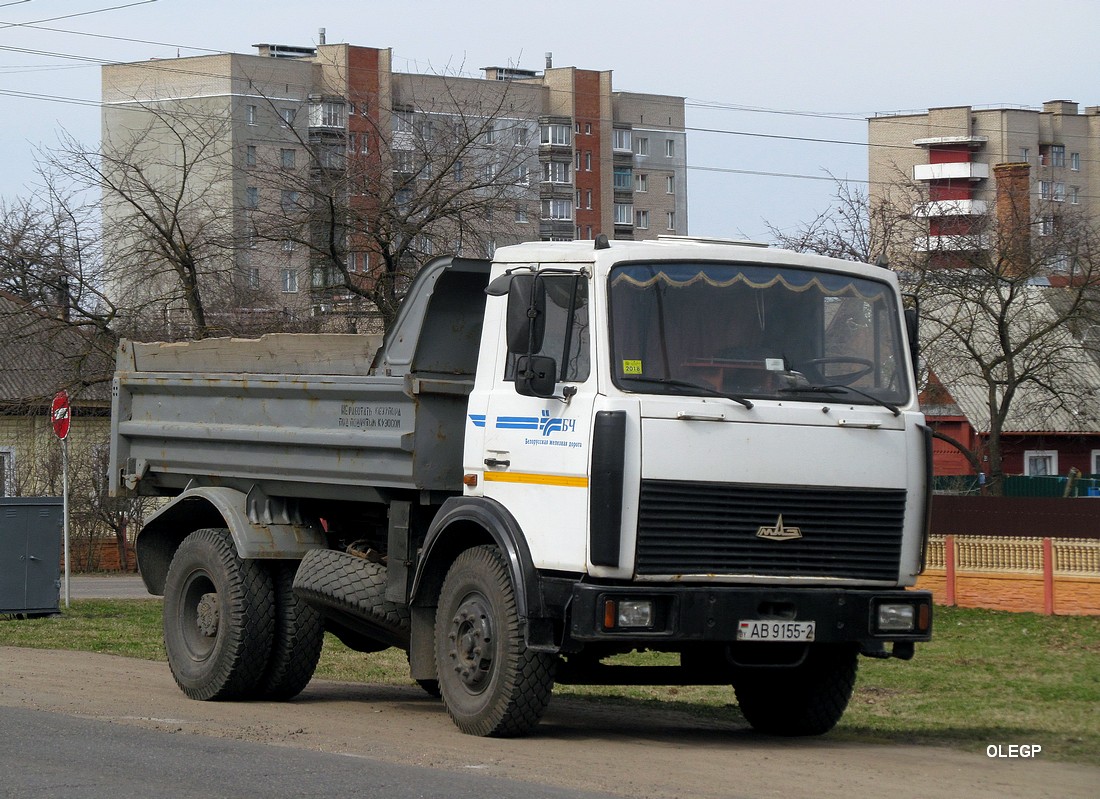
<box><xmin>0</xmin><ymin>0</ymin><xmax>1100</xmax><ymax>240</ymax></box>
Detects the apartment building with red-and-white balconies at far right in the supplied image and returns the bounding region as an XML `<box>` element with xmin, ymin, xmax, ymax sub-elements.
<box><xmin>868</xmin><ymin>100</ymin><xmax>1100</xmax><ymax>263</ymax></box>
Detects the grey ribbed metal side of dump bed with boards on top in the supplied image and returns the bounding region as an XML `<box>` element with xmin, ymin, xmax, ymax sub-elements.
<box><xmin>111</xmin><ymin>333</ymin><xmax>472</xmax><ymax>500</ymax></box>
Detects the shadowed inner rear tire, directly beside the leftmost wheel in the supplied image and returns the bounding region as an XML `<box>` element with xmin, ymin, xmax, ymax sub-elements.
<box><xmin>256</xmin><ymin>560</ymin><xmax>325</xmax><ymax>701</ymax></box>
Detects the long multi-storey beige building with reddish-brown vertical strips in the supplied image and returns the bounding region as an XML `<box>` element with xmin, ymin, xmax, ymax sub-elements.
<box><xmin>102</xmin><ymin>36</ymin><xmax>688</xmax><ymax>327</ymax></box>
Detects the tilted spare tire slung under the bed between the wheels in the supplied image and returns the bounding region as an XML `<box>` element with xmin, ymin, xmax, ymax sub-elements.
<box><xmin>294</xmin><ymin>549</ymin><xmax>409</xmax><ymax>649</ymax></box>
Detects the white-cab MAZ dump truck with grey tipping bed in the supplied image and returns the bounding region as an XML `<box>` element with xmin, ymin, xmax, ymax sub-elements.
<box><xmin>111</xmin><ymin>237</ymin><xmax>932</xmax><ymax>735</ymax></box>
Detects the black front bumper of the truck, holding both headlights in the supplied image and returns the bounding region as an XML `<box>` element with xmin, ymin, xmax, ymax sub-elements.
<box><xmin>569</xmin><ymin>583</ymin><xmax>932</xmax><ymax>652</ymax></box>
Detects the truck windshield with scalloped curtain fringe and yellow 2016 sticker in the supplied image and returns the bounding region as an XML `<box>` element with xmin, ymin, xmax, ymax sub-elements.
<box><xmin>611</xmin><ymin>262</ymin><xmax>910</xmax><ymax>404</ymax></box>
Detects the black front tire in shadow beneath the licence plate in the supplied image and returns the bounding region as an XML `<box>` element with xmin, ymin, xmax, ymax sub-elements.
<box><xmin>734</xmin><ymin>644</ymin><xmax>859</xmax><ymax>737</ymax></box>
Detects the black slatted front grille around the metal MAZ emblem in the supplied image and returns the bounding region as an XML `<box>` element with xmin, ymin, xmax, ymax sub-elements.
<box><xmin>635</xmin><ymin>480</ymin><xmax>905</xmax><ymax>582</ymax></box>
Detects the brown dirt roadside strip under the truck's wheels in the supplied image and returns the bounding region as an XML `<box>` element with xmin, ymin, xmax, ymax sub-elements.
<box><xmin>0</xmin><ymin>647</ymin><xmax>1100</xmax><ymax>799</ymax></box>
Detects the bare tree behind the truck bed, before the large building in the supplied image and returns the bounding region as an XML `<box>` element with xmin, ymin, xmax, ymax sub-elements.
<box><xmin>253</xmin><ymin>68</ymin><xmax>541</xmax><ymax>326</ymax></box>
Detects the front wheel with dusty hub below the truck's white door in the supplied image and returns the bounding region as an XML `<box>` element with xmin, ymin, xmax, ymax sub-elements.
<box><xmin>436</xmin><ymin>546</ymin><xmax>558</xmax><ymax>737</ymax></box>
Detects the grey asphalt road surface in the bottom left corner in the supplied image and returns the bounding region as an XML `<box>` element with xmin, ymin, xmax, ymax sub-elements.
<box><xmin>0</xmin><ymin>707</ymin><xmax>612</xmax><ymax>799</ymax></box>
